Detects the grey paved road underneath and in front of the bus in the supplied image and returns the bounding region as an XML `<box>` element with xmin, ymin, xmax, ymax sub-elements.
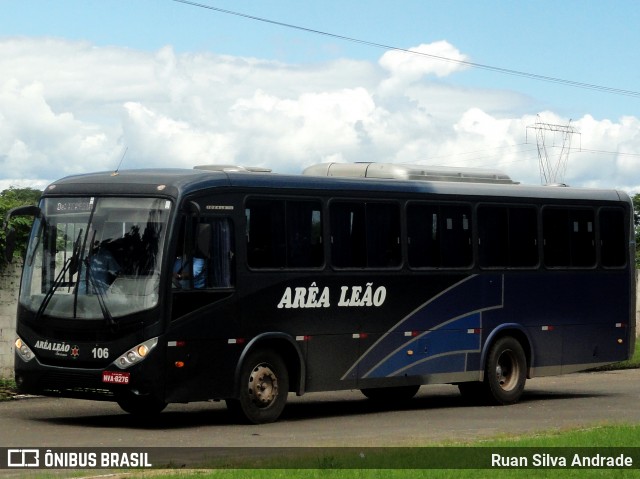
<box><xmin>0</xmin><ymin>370</ymin><xmax>640</xmax><ymax>447</ymax></box>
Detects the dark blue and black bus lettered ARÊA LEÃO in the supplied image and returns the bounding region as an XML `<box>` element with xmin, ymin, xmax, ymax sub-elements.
<box><xmin>7</xmin><ymin>163</ymin><xmax>635</xmax><ymax>424</ymax></box>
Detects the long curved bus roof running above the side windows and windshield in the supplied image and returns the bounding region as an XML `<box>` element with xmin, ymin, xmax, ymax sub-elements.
<box><xmin>44</xmin><ymin>168</ymin><xmax>630</xmax><ymax>202</ymax></box>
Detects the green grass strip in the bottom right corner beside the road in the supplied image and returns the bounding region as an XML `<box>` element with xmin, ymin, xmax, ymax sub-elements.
<box><xmin>112</xmin><ymin>425</ymin><xmax>640</xmax><ymax>479</ymax></box>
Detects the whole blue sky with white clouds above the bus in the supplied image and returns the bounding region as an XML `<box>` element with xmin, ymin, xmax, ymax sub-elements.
<box><xmin>0</xmin><ymin>0</ymin><xmax>640</xmax><ymax>194</ymax></box>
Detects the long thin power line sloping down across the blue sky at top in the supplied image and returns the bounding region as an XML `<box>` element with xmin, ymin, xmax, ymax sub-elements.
<box><xmin>173</xmin><ymin>0</ymin><xmax>640</xmax><ymax>98</ymax></box>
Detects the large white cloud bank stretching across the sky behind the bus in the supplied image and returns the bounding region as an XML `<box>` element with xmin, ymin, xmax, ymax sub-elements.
<box><xmin>0</xmin><ymin>38</ymin><xmax>640</xmax><ymax>191</ymax></box>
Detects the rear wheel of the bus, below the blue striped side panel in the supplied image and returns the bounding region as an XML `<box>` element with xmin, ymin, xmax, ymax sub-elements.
<box><xmin>485</xmin><ymin>336</ymin><xmax>527</xmax><ymax>405</ymax></box>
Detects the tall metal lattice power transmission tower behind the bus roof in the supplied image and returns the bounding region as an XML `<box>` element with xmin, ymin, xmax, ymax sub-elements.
<box><xmin>527</xmin><ymin>115</ymin><xmax>580</xmax><ymax>185</ymax></box>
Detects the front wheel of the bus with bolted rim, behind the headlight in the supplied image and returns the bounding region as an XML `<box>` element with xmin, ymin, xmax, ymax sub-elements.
<box><xmin>226</xmin><ymin>350</ymin><xmax>289</xmax><ymax>424</ymax></box>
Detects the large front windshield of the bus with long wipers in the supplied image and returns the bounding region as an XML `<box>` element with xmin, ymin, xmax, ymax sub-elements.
<box><xmin>19</xmin><ymin>197</ymin><xmax>171</xmax><ymax>324</ymax></box>
